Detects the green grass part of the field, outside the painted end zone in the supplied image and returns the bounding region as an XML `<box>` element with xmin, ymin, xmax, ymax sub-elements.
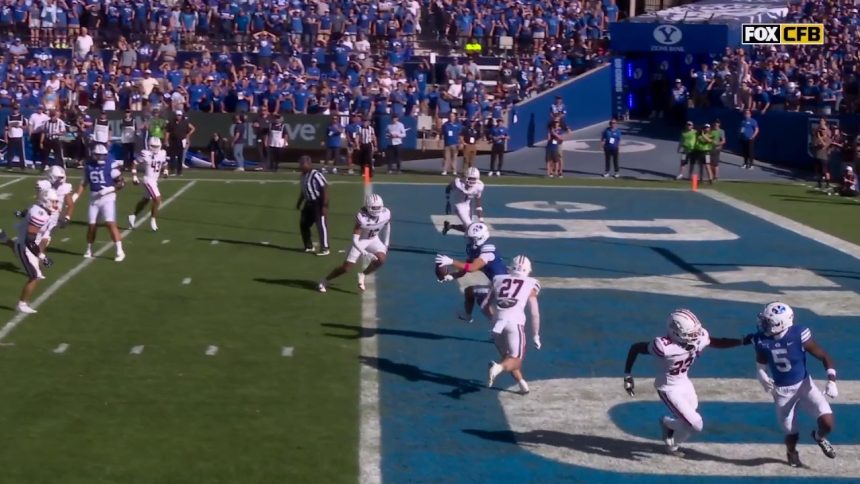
<box><xmin>0</xmin><ymin>168</ymin><xmax>860</xmax><ymax>484</ymax></box>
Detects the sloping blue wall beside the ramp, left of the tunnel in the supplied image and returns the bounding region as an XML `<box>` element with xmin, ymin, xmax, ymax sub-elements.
<box><xmin>508</xmin><ymin>64</ymin><xmax>612</xmax><ymax>151</ymax></box>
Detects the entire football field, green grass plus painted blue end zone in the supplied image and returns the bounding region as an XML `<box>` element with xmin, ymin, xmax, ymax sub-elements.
<box><xmin>0</xmin><ymin>172</ymin><xmax>860</xmax><ymax>483</ymax></box>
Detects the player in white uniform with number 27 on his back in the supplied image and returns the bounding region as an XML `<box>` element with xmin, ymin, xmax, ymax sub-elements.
<box><xmin>487</xmin><ymin>255</ymin><xmax>541</xmax><ymax>395</ymax></box>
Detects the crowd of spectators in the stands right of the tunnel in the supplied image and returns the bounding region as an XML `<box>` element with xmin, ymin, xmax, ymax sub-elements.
<box><xmin>684</xmin><ymin>0</ymin><xmax>860</xmax><ymax>115</ymax></box>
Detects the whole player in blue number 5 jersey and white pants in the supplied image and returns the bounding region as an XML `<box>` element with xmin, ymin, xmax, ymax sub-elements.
<box><xmin>753</xmin><ymin>301</ymin><xmax>839</xmax><ymax>467</ymax></box>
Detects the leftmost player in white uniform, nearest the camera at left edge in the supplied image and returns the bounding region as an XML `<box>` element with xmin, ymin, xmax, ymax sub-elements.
<box><xmin>14</xmin><ymin>188</ymin><xmax>60</xmax><ymax>314</ymax></box>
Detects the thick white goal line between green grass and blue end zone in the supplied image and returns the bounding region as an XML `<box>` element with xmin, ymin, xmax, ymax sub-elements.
<box><xmin>358</xmin><ymin>274</ymin><xmax>382</xmax><ymax>484</ymax></box>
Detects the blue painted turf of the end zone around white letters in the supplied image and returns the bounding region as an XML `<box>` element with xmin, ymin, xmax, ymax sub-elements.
<box><xmin>365</xmin><ymin>185</ymin><xmax>860</xmax><ymax>482</ymax></box>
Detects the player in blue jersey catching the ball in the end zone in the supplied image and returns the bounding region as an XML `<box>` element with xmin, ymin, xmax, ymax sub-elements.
<box><xmin>436</xmin><ymin>222</ymin><xmax>508</xmax><ymax>323</ymax></box>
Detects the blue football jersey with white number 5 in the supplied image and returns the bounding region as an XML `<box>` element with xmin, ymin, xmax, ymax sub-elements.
<box><xmin>753</xmin><ymin>326</ymin><xmax>812</xmax><ymax>387</ymax></box>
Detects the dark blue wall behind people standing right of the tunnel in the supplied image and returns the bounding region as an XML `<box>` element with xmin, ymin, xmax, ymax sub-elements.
<box><xmin>687</xmin><ymin>109</ymin><xmax>860</xmax><ymax>169</ymax></box>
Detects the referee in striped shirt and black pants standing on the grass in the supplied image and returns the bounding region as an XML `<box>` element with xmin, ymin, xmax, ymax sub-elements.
<box><xmin>296</xmin><ymin>155</ymin><xmax>329</xmax><ymax>255</ymax></box>
